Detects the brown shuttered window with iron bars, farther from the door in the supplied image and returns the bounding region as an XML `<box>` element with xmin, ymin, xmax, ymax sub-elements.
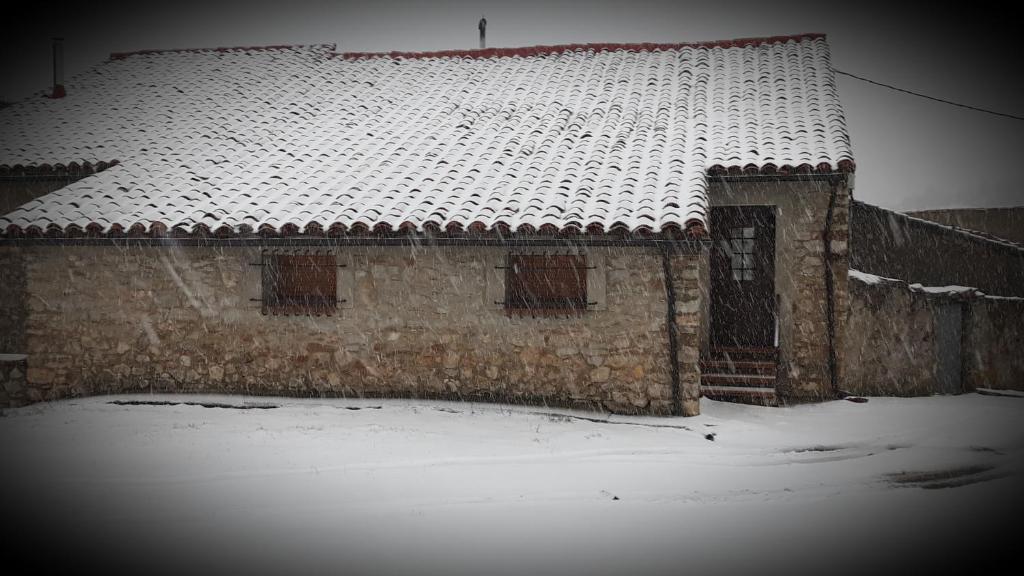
<box><xmin>263</xmin><ymin>254</ymin><xmax>338</xmax><ymax>316</ymax></box>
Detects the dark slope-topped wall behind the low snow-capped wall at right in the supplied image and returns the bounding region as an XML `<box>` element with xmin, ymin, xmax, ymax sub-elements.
<box><xmin>850</xmin><ymin>202</ymin><xmax>1024</xmax><ymax>296</ymax></box>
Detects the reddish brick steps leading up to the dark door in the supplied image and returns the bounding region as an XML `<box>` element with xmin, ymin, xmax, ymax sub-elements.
<box><xmin>700</xmin><ymin>347</ymin><xmax>778</xmax><ymax>406</ymax></box>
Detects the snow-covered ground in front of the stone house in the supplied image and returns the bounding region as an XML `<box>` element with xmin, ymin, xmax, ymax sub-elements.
<box><xmin>0</xmin><ymin>394</ymin><xmax>1024</xmax><ymax>576</ymax></box>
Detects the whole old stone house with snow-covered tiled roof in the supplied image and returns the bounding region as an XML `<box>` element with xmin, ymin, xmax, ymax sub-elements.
<box><xmin>0</xmin><ymin>34</ymin><xmax>854</xmax><ymax>415</ymax></box>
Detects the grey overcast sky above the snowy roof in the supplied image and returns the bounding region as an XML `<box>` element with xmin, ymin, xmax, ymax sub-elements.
<box><xmin>0</xmin><ymin>0</ymin><xmax>1024</xmax><ymax>210</ymax></box>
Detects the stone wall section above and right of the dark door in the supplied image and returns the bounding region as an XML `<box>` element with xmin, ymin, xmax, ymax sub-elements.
<box><xmin>706</xmin><ymin>178</ymin><xmax>850</xmax><ymax>402</ymax></box>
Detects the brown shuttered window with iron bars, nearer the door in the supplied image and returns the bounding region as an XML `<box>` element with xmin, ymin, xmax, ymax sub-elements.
<box><xmin>505</xmin><ymin>254</ymin><xmax>587</xmax><ymax>316</ymax></box>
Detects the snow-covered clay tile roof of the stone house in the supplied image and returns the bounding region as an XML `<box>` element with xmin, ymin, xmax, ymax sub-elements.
<box><xmin>0</xmin><ymin>35</ymin><xmax>853</xmax><ymax>234</ymax></box>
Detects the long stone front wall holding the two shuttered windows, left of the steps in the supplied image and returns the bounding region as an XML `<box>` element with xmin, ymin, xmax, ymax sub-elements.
<box><xmin>8</xmin><ymin>239</ymin><xmax>702</xmax><ymax>414</ymax></box>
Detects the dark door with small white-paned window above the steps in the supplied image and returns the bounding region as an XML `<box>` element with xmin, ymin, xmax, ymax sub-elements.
<box><xmin>711</xmin><ymin>206</ymin><xmax>775</xmax><ymax>347</ymax></box>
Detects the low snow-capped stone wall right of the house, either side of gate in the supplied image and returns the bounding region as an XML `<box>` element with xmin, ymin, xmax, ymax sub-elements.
<box><xmin>842</xmin><ymin>278</ymin><xmax>1024</xmax><ymax>396</ymax></box>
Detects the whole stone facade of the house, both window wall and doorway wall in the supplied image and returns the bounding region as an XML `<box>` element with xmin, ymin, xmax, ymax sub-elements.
<box><xmin>0</xmin><ymin>177</ymin><xmax>849</xmax><ymax>414</ymax></box>
